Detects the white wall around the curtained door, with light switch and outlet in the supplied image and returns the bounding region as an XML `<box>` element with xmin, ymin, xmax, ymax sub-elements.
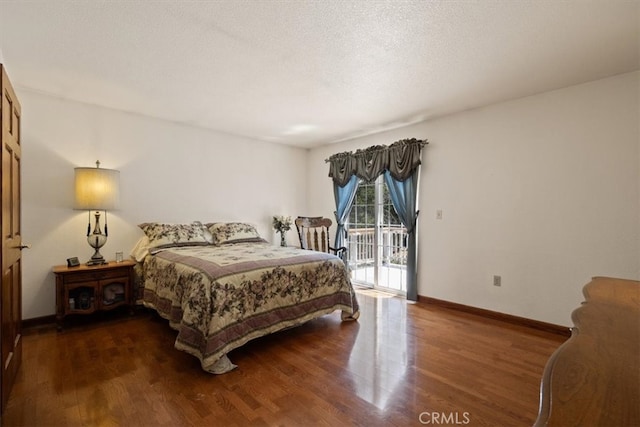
<box><xmin>307</xmin><ymin>72</ymin><xmax>640</xmax><ymax>325</ymax></box>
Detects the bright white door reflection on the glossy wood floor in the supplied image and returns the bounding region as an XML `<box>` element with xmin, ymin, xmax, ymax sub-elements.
<box><xmin>349</xmin><ymin>290</ymin><xmax>409</xmax><ymax>410</ymax></box>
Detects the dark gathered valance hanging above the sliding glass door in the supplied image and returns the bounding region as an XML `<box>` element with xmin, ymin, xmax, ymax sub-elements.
<box><xmin>325</xmin><ymin>138</ymin><xmax>428</xmax><ymax>187</ymax></box>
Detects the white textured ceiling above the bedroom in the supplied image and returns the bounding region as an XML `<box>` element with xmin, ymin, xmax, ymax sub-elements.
<box><xmin>0</xmin><ymin>0</ymin><xmax>640</xmax><ymax>147</ymax></box>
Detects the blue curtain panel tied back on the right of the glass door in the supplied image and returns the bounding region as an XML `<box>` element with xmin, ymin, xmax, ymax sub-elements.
<box><xmin>384</xmin><ymin>167</ymin><xmax>420</xmax><ymax>301</ymax></box>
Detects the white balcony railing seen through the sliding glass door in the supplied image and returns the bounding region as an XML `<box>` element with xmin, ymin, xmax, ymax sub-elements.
<box><xmin>348</xmin><ymin>225</ymin><xmax>407</xmax><ymax>268</ymax></box>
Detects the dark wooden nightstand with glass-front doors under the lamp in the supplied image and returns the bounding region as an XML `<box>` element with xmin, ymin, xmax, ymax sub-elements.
<box><xmin>53</xmin><ymin>260</ymin><xmax>135</xmax><ymax>331</ymax></box>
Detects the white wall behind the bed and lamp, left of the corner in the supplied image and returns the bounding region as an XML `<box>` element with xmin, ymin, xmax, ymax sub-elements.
<box><xmin>16</xmin><ymin>93</ymin><xmax>306</xmax><ymax>319</ymax></box>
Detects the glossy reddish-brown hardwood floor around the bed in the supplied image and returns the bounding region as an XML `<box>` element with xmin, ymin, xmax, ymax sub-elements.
<box><xmin>2</xmin><ymin>292</ymin><xmax>565</xmax><ymax>426</ymax></box>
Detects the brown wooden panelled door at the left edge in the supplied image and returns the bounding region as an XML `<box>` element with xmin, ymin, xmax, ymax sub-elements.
<box><xmin>0</xmin><ymin>64</ymin><xmax>23</xmax><ymax>412</ymax></box>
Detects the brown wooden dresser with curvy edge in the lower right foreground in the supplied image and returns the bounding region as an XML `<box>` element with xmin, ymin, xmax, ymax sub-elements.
<box><xmin>535</xmin><ymin>277</ymin><xmax>640</xmax><ymax>427</ymax></box>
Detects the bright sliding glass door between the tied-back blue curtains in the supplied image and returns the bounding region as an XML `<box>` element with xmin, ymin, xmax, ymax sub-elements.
<box><xmin>347</xmin><ymin>176</ymin><xmax>407</xmax><ymax>294</ymax></box>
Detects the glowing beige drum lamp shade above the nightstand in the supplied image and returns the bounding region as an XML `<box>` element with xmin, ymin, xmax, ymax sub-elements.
<box><xmin>74</xmin><ymin>167</ymin><xmax>120</xmax><ymax>211</ymax></box>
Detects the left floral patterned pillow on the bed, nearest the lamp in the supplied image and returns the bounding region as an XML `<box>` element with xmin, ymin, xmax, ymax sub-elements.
<box><xmin>138</xmin><ymin>221</ymin><xmax>213</xmax><ymax>250</ymax></box>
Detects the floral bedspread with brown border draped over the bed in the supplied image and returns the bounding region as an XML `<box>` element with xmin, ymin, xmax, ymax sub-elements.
<box><xmin>143</xmin><ymin>243</ymin><xmax>359</xmax><ymax>373</ymax></box>
